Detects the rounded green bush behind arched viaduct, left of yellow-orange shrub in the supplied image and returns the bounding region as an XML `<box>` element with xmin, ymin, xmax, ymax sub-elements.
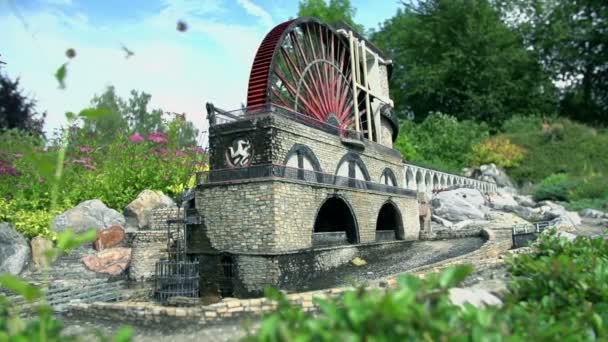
<box><xmin>395</xmin><ymin>113</ymin><xmax>489</xmax><ymax>173</ymax></box>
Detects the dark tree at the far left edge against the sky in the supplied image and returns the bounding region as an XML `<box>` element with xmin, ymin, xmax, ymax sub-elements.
<box><xmin>0</xmin><ymin>72</ymin><xmax>46</xmax><ymax>136</ymax></box>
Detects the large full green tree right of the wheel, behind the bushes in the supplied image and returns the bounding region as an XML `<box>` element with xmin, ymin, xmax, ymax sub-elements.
<box><xmin>372</xmin><ymin>0</ymin><xmax>555</xmax><ymax>128</ymax></box>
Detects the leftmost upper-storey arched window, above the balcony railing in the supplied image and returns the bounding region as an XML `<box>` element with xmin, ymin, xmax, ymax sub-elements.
<box><xmin>283</xmin><ymin>144</ymin><xmax>323</xmax><ymax>181</ymax></box>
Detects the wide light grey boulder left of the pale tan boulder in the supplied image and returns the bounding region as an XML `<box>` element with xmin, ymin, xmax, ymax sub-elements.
<box><xmin>51</xmin><ymin>199</ymin><xmax>125</xmax><ymax>233</ymax></box>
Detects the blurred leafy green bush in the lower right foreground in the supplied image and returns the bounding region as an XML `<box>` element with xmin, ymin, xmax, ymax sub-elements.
<box><xmin>248</xmin><ymin>233</ymin><xmax>608</xmax><ymax>341</ymax></box>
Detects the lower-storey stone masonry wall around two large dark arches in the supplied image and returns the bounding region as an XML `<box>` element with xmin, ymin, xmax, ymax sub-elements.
<box><xmin>193</xmin><ymin>179</ymin><xmax>420</xmax><ymax>254</ymax></box>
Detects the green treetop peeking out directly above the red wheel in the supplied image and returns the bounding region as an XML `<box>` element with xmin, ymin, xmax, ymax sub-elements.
<box><xmin>298</xmin><ymin>0</ymin><xmax>364</xmax><ymax>32</ymax></box>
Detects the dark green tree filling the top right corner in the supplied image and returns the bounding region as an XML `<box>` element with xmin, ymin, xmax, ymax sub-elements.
<box><xmin>497</xmin><ymin>0</ymin><xmax>608</xmax><ymax>123</ymax></box>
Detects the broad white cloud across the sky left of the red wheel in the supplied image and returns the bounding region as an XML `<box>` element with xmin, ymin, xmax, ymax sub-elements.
<box><xmin>0</xmin><ymin>0</ymin><xmax>267</xmax><ymax>145</ymax></box>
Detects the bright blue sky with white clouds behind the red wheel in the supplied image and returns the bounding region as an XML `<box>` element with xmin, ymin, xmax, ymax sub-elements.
<box><xmin>0</xmin><ymin>0</ymin><xmax>399</xmax><ymax>143</ymax></box>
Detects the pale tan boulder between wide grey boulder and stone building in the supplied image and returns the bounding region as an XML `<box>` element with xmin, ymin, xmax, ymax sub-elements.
<box><xmin>124</xmin><ymin>190</ymin><xmax>176</xmax><ymax>229</ymax></box>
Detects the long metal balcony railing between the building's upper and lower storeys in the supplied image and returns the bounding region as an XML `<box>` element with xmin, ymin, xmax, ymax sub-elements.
<box><xmin>196</xmin><ymin>164</ymin><xmax>416</xmax><ymax>196</ymax></box>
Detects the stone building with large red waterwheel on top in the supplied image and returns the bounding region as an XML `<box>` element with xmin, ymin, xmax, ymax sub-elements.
<box><xmin>186</xmin><ymin>18</ymin><xmax>494</xmax><ymax>297</ymax></box>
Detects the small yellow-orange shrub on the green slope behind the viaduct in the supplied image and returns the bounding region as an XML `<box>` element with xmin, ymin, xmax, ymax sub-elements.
<box><xmin>472</xmin><ymin>136</ymin><xmax>526</xmax><ymax>168</ymax></box>
